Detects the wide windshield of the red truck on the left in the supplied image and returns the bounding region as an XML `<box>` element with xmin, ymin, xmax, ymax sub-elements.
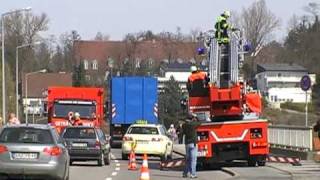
<box><xmin>54</xmin><ymin>103</ymin><xmax>96</xmax><ymax>119</ymax></box>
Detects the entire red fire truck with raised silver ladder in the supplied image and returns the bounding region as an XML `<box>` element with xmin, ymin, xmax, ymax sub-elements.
<box><xmin>188</xmin><ymin>29</ymin><xmax>269</xmax><ymax>166</ymax></box>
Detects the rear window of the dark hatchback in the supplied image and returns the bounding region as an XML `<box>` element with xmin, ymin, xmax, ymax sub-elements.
<box><xmin>63</xmin><ymin>128</ymin><xmax>96</xmax><ymax>139</ymax></box>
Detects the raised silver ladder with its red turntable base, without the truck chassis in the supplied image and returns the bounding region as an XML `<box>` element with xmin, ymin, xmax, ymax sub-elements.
<box><xmin>189</xmin><ymin>31</ymin><xmax>261</xmax><ymax>119</ymax></box>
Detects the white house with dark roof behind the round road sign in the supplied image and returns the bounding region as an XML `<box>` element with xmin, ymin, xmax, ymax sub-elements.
<box><xmin>255</xmin><ymin>64</ymin><xmax>315</xmax><ymax>104</ymax></box>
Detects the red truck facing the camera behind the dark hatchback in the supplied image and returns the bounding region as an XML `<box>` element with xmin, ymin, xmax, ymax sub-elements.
<box><xmin>47</xmin><ymin>87</ymin><xmax>104</xmax><ymax>132</ymax></box>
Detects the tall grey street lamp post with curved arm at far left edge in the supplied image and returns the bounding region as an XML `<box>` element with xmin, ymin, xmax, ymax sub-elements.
<box><xmin>1</xmin><ymin>7</ymin><xmax>31</xmax><ymax>124</ymax></box>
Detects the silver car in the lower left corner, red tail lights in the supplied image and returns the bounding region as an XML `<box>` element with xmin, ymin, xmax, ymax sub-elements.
<box><xmin>0</xmin><ymin>124</ymin><xmax>69</xmax><ymax>180</ymax></box>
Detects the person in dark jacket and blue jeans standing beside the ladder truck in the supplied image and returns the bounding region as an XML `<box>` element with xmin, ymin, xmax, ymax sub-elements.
<box><xmin>182</xmin><ymin>113</ymin><xmax>200</xmax><ymax>179</ymax></box>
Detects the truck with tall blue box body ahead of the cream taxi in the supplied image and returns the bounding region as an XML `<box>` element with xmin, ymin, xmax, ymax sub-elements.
<box><xmin>109</xmin><ymin>77</ymin><xmax>158</xmax><ymax>146</ymax></box>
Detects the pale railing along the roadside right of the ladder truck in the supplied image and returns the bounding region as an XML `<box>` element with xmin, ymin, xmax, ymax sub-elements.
<box><xmin>268</xmin><ymin>125</ymin><xmax>313</xmax><ymax>151</ymax></box>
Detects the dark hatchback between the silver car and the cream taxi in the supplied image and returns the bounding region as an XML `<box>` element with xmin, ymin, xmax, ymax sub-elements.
<box><xmin>62</xmin><ymin>126</ymin><xmax>111</xmax><ymax>166</ymax></box>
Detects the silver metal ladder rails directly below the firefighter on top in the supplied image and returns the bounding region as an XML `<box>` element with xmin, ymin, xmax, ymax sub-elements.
<box><xmin>209</xmin><ymin>34</ymin><xmax>239</xmax><ymax>88</ymax></box>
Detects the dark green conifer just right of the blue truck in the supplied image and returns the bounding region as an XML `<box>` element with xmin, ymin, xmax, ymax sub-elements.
<box><xmin>159</xmin><ymin>76</ymin><xmax>182</xmax><ymax>127</ymax></box>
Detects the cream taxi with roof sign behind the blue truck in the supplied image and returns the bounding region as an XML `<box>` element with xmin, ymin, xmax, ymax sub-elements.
<box><xmin>122</xmin><ymin>124</ymin><xmax>173</xmax><ymax>161</ymax></box>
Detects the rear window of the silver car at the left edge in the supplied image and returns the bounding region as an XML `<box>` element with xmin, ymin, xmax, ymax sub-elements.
<box><xmin>0</xmin><ymin>127</ymin><xmax>53</xmax><ymax>144</ymax></box>
